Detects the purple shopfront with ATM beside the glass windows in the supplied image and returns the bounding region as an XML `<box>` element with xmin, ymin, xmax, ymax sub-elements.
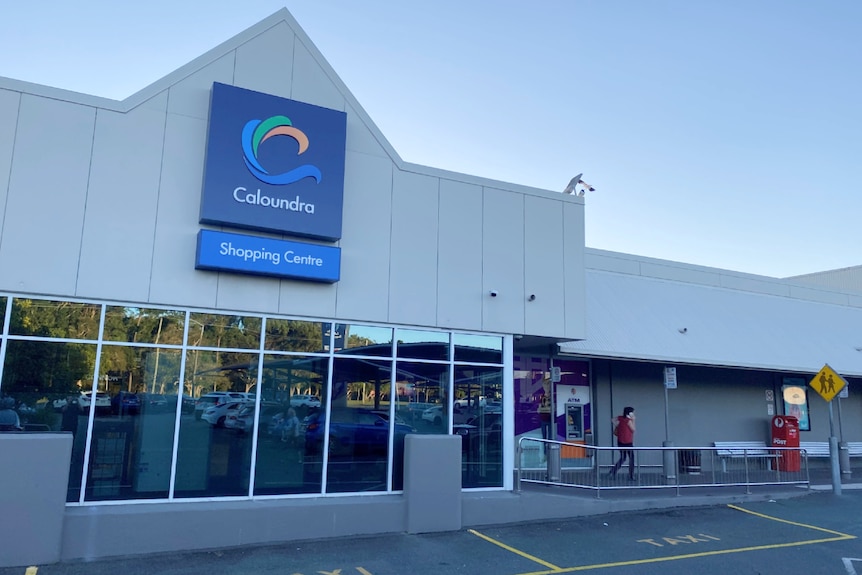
<box><xmin>514</xmin><ymin>355</ymin><xmax>592</xmax><ymax>459</ymax></box>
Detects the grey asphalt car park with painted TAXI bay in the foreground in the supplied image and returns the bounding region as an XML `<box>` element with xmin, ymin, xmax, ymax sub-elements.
<box><xmin>8</xmin><ymin>491</ymin><xmax>862</xmax><ymax>575</ymax></box>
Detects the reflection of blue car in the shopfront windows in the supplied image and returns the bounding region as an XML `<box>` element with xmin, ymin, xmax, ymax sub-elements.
<box><xmin>303</xmin><ymin>409</ymin><xmax>416</xmax><ymax>457</ymax></box>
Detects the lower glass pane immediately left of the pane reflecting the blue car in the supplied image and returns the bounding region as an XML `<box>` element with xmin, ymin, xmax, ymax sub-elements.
<box><xmin>253</xmin><ymin>355</ymin><xmax>329</xmax><ymax>495</ymax></box>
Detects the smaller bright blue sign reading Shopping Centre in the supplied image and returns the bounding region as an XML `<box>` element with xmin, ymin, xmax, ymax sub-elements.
<box><xmin>195</xmin><ymin>230</ymin><xmax>341</xmax><ymax>283</ymax></box>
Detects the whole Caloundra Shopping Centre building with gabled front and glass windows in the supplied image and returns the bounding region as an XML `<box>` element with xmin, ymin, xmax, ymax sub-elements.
<box><xmin>0</xmin><ymin>6</ymin><xmax>862</xmax><ymax>566</ymax></box>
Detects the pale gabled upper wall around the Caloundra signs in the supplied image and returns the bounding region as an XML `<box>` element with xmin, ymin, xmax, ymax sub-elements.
<box><xmin>0</xmin><ymin>11</ymin><xmax>585</xmax><ymax>339</ymax></box>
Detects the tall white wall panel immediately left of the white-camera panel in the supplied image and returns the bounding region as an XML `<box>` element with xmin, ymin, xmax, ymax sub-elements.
<box><xmin>437</xmin><ymin>179</ymin><xmax>487</xmax><ymax>331</ymax></box>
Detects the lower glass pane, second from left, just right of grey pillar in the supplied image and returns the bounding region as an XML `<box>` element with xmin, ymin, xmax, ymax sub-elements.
<box><xmin>84</xmin><ymin>345</ymin><xmax>182</xmax><ymax>501</ymax></box>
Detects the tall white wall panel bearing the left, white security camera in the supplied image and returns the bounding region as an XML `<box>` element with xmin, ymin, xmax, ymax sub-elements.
<box><xmin>482</xmin><ymin>188</ymin><xmax>524</xmax><ymax>334</ymax></box>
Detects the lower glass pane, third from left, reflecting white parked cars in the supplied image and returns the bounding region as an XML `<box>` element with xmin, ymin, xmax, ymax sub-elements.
<box><xmin>174</xmin><ymin>350</ymin><xmax>258</xmax><ymax>497</ymax></box>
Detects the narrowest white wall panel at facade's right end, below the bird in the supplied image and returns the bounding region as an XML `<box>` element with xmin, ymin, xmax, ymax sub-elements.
<box><xmin>562</xmin><ymin>203</ymin><xmax>587</xmax><ymax>339</ymax></box>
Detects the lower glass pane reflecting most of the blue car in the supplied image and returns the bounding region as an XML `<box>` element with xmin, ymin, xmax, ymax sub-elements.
<box><xmin>330</xmin><ymin>358</ymin><xmax>404</xmax><ymax>493</ymax></box>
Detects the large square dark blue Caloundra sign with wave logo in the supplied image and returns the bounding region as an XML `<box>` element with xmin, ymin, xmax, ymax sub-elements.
<box><xmin>200</xmin><ymin>83</ymin><xmax>347</xmax><ymax>241</ymax></box>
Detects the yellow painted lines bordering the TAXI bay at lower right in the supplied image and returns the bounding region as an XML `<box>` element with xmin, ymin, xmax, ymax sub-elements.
<box><xmin>486</xmin><ymin>505</ymin><xmax>856</xmax><ymax>575</ymax></box>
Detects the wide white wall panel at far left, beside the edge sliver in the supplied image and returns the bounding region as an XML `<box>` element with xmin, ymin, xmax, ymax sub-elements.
<box><xmin>0</xmin><ymin>95</ymin><xmax>96</xmax><ymax>295</ymax></box>
